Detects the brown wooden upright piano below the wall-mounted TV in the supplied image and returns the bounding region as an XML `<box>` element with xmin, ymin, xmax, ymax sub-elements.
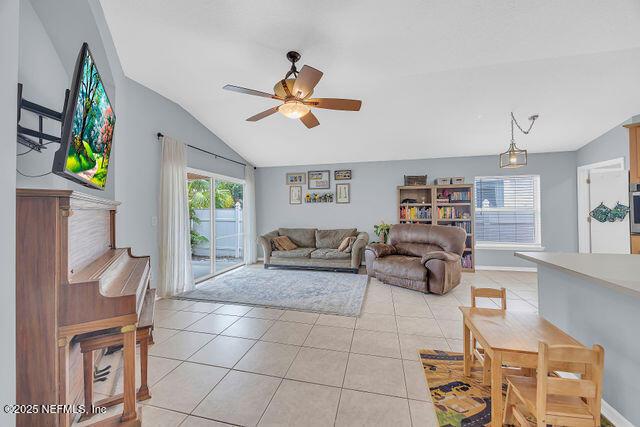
<box><xmin>16</xmin><ymin>189</ymin><xmax>153</xmax><ymax>426</ymax></box>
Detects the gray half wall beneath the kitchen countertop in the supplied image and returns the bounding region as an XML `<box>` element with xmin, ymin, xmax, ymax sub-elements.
<box><xmin>538</xmin><ymin>264</ymin><xmax>640</xmax><ymax>426</ymax></box>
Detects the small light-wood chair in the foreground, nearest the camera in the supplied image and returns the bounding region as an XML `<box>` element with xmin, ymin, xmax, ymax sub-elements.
<box><xmin>503</xmin><ymin>342</ymin><xmax>604</xmax><ymax>427</ymax></box>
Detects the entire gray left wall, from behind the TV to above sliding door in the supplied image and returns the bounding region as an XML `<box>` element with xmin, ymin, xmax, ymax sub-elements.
<box><xmin>16</xmin><ymin>0</ymin><xmax>244</xmax><ymax>290</ymax></box>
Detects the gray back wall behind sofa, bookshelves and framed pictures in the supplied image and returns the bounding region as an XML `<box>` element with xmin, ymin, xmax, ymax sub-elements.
<box><xmin>256</xmin><ymin>152</ymin><xmax>578</xmax><ymax>267</ymax></box>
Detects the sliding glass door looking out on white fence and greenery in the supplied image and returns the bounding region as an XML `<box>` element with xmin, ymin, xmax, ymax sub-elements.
<box><xmin>187</xmin><ymin>168</ymin><xmax>244</xmax><ymax>283</ymax></box>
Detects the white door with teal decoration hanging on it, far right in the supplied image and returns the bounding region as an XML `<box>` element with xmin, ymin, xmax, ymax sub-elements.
<box><xmin>578</xmin><ymin>157</ymin><xmax>630</xmax><ymax>253</ymax></box>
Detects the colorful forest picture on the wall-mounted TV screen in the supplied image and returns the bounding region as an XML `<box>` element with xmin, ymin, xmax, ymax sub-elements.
<box><xmin>66</xmin><ymin>51</ymin><xmax>116</xmax><ymax>188</ymax></box>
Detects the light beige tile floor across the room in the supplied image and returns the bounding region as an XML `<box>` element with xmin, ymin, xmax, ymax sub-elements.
<box><xmin>75</xmin><ymin>271</ymin><xmax>538</xmax><ymax>427</ymax></box>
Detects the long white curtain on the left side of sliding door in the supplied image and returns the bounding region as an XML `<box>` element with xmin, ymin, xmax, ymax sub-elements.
<box><xmin>158</xmin><ymin>136</ymin><xmax>194</xmax><ymax>297</ymax></box>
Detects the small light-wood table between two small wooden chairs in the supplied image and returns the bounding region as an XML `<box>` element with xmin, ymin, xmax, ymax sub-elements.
<box><xmin>460</xmin><ymin>307</ymin><xmax>582</xmax><ymax>427</ymax></box>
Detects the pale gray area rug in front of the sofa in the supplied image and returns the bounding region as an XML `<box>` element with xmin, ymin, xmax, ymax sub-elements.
<box><xmin>177</xmin><ymin>267</ymin><xmax>369</xmax><ymax>316</ymax></box>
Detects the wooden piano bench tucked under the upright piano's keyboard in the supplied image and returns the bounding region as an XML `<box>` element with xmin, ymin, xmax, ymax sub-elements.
<box><xmin>76</xmin><ymin>323</ymin><xmax>153</xmax><ymax>421</ymax></box>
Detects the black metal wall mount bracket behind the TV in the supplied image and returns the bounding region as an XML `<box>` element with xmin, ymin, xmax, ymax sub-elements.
<box><xmin>17</xmin><ymin>83</ymin><xmax>69</xmax><ymax>152</ymax></box>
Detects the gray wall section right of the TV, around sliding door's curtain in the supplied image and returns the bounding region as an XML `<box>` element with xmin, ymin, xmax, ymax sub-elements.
<box><xmin>114</xmin><ymin>78</ymin><xmax>244</xmax><ymax>288</ymax></box>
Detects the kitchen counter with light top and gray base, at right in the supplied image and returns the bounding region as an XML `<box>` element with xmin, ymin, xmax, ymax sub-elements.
<box><xmin>516</xmin><ymin>252</ymin><xmax>640</xmax><ymax>426</ymax></box>
